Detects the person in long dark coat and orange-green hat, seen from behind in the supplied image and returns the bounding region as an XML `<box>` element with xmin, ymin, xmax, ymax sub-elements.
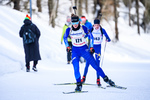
<box><xmin>19</xmin><ymin>15</ymin><xmax>41</xmax><ymax>72</ymax></box>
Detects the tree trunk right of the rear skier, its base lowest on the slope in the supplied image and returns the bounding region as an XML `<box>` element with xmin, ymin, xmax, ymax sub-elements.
<box><xmin>114</xmin><ymin>0</ymin><xmax>119</xmax><ymax>41</ymax></box>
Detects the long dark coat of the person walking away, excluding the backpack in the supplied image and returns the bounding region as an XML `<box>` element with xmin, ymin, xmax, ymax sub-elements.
<box><xmin>19</xmin><ymin>19</ymin><xmax>41</xmax><ymax>63</ymax></box>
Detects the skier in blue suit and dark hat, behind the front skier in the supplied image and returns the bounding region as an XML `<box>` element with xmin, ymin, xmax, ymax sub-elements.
<box><xmin>81</xmin><ymin>19</ymin><xmax>111</xmax><ymax>86</ymax></box>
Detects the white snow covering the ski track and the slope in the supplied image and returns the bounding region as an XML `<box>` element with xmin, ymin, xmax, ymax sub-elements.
<box><xmin>0</xmin><ymin>2</ymin><xmax>150</xmax><ymax>100</ymax></box>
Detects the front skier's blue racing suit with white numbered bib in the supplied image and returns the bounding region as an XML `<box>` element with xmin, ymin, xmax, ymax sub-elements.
<box><xmin>64</xmin><ymin>25</ymin><xmax>106</xmax><ymax>82</ymax></box>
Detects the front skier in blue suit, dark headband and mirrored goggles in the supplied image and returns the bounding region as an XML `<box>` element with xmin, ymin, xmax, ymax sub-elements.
<box><xmin>64</xmin><ymin>14</ymin><xmax>115</xmax><ymax>91</ymax></box>
